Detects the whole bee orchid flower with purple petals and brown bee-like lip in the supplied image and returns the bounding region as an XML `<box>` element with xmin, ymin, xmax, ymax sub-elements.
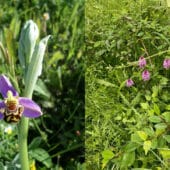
<box><xmin>0</xmin><ymin>75</ymin><xmax>42</xmax><ymax>123</ymax></box>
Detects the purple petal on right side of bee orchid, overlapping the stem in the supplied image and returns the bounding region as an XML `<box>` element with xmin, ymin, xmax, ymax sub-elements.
<box><xmin>19</xmin><ymin>97</ymin><xmax>42</xmax><ymax>118</ymax></box>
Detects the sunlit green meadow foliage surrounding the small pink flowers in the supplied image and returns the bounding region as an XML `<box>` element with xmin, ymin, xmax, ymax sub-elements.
<box><xmin>85</xmin><ymin>0</ymin><xmax>170</xmax><ymax>170</ymax></box>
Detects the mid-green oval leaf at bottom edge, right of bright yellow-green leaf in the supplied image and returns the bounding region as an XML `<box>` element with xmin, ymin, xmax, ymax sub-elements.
<box><xmin>121</xmin><ymin>152</ymin><xmax>135</xmax><ymax>168</ymax></box>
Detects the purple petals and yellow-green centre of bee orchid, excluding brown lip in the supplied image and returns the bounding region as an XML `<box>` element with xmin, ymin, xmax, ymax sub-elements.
<box><xmin>0</xmin><ymin>75</ymin><xmax>42</xmax><ymax>119</ymax></box>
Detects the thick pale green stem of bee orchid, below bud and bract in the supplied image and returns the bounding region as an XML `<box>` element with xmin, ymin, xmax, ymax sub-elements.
<box><xmin>18</xmin><ymin>84</ymin><xmax>33</xmax><ymax>170</ymax></box>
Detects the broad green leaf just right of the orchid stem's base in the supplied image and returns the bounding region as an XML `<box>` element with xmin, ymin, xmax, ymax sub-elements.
<box><xmin>30</xmin><ymin>148</ymin><xmax>52</xmax><ymax>168</ymax></box>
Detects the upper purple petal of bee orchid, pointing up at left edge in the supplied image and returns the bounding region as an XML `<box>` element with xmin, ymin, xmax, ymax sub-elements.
<box><xmin>0</xmin><ymin>75</ymin><xmax>18</xmax><ymax>98</ymax></box>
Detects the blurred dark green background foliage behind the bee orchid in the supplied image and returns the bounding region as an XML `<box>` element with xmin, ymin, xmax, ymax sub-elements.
<box><xmin>0</xmin><ymin>0</ymin><xmax>84</xmax><ymax>170</ymax></box>
